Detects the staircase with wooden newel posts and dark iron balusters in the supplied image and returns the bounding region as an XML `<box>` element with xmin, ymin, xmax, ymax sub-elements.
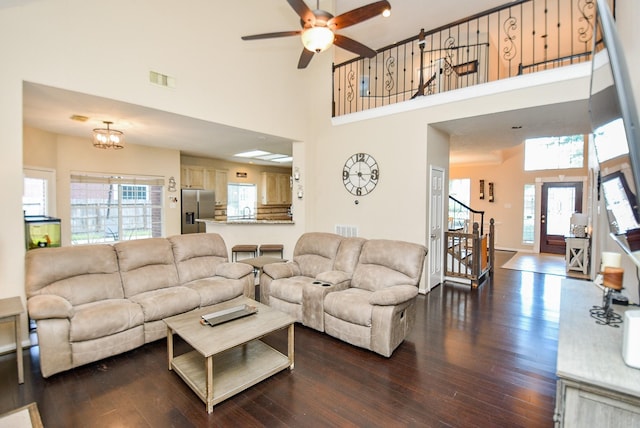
<box><xmin>445</xmin><ymin>196</ymin><xmax>495</xmax><ymax>288</ymax></box>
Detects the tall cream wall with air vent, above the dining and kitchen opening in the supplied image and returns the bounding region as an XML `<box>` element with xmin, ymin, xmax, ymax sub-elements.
<box><xmin>0</xmin><ymin>0</ymin><xmax>314</xmax><ymax>347</ymax></box>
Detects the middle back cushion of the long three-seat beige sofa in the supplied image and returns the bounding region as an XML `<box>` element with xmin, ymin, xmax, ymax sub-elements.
<box><xmin>114</xmin><ymin>238</ymin><xmax>179</xmax><ymax>298</ymax></box>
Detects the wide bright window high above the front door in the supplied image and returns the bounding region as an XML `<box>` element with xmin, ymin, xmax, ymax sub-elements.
<box><xmin>524</xmin><ymin>135</ymin><xmax>584</xmax><ymax>171</ymax></box>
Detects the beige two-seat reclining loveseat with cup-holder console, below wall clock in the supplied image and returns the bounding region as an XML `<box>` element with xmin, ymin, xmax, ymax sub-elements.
<box><xmin>260</xmin><ymin>233</ymin><xmax>427</xmax><ymax>357</ymax></box>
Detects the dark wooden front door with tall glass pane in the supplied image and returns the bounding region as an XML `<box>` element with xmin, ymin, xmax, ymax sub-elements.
<box><xmin>540</xmin><ymin>182</ymin><xmax>582</xmax><ymax>254</ymax></box>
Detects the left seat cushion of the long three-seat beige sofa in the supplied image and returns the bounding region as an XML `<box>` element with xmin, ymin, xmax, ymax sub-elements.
<box><xmin>69</xmin><ymin>299</ymin><xmax>144</xmax><ymax>342</ymax></box>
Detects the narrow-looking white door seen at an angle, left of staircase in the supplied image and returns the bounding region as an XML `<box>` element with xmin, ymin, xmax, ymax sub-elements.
<box><xmin>427</xmin><ymin>166</ymin><xmax>444</xmax><ymax>290</ymax></box>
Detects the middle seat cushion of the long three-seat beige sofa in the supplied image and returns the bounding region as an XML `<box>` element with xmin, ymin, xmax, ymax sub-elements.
<box><xmin>129</xmin><ymin>286</ymin><xmax>200</xmax><ymax>322</ymax></box>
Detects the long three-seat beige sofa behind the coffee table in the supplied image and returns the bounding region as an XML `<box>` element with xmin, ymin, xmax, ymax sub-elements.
<box><xmin>25</xmin><ymin>233</ymin><xmax>255</xmax><ymax>377</ymax></box>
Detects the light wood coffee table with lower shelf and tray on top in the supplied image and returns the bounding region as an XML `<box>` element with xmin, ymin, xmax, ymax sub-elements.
<box><xmin>164</xmin><ymin>297</ymin><xmax>295</xmax><ymax>413</ymax></box>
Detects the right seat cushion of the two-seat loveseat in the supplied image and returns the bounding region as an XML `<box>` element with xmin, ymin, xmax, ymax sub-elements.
<box><xmin>324</xmin><ymin>288</ymin><xmax>373</xmax><ymax>327</ymax></box>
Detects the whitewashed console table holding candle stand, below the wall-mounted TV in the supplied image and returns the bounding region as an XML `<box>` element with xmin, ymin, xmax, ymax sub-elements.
<box><xmin>554</xmin><ymin>279</ymin><xmax>640</xmax><ymax>427</ymax></box>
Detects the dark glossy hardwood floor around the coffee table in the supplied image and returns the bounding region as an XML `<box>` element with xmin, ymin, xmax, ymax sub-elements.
<box><xmin>0</xmin><ymin>252</ymin><xmax>562</xmax><ymax>428</ymax></box>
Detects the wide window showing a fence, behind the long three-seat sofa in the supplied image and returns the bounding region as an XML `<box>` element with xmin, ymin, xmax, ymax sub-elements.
<box><xmin>71</xmin><ymin>174</ymin><xmax>164</xmax><ymax>245</ymax></box>
